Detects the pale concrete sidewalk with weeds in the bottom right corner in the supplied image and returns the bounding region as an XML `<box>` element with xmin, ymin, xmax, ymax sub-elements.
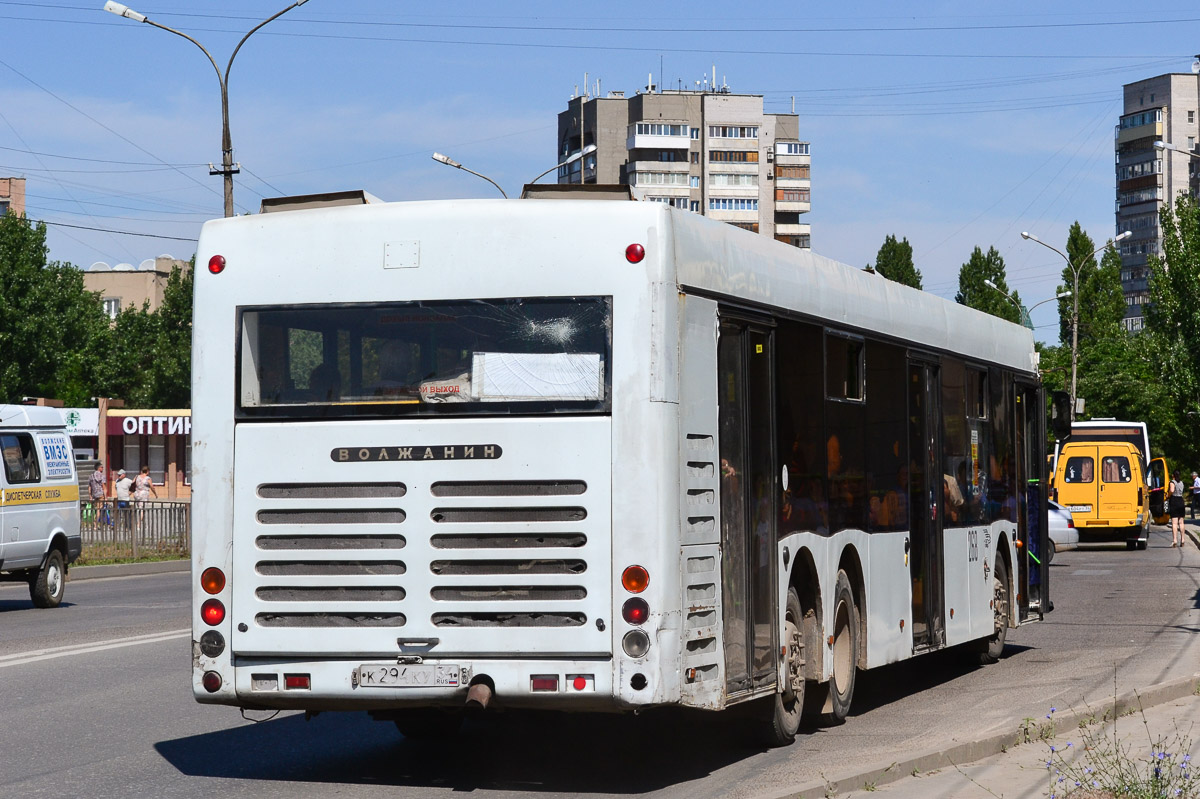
<box><xmin>830</xmin><ymin>679</ymin><xmax>1200</xmax><ymax>799</ymax></box>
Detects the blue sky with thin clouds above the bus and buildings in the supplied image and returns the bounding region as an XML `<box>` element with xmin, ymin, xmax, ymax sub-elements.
<box><xmin>0</xmin><ymin>0</ymin><xmax>1200</xmax><ymax>338</ymax></box>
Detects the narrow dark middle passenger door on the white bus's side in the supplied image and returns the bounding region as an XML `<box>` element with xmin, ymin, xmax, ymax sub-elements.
<box><xmin>908</xmin><ymin>361</ymin><xmax>946</xmax><ymax>649</ymax></box>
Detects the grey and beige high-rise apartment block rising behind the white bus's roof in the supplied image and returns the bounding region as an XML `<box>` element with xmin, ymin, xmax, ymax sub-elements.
<box><xmin>557</xmin><ymin>86</ymin><xmax>811</xmax><ymax>247</ymax></box>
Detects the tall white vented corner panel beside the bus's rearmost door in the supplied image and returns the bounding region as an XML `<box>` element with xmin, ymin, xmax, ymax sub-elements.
<box><xmin>679</xmin><ymin>295</ymin><xmax>725</xmax><ymax>709</ymax></box>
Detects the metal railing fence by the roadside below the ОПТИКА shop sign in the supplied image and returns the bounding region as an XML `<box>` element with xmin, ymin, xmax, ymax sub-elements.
<box><xmin>79</xmin><ymin>499</ymin><xmax>192</xmax><ymax>560</ymax></box>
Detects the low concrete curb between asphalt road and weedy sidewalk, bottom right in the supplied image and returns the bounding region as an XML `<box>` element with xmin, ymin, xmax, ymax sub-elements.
<box><xmin>757</xmin><ymin>671</ymin><xmax>1200</xmax><ymax>799</ymax></box>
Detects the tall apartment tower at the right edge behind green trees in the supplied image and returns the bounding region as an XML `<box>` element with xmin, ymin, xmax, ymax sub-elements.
<box><xmin>1116</xmin><ymin>73</ymin><xmax>1200</xmax><ymax>330</ymax></box>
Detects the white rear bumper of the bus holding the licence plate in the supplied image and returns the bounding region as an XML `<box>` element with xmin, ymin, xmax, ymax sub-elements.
<box><xmin>208</xmin><ymin>656</ymin><xmax>630</xmax><ymax>711</ymax></box>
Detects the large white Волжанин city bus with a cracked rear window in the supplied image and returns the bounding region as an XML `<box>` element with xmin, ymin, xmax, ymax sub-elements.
<box><xmin>192</xmin><ymin>199</ymin><xmax>1049</xmax><ymax>744</ymax></box>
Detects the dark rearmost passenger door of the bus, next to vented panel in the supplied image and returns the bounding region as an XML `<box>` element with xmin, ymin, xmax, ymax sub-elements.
<box><xmin>716</xmin><ymin>319</ymin><xmax>780</xmax><ymax>696</ymax></box>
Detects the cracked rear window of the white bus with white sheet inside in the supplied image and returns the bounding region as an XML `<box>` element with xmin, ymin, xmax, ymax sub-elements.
<box><xmin>238</xmin><ymin>298</ymin><xmax>612</xmax><ymax>416</ymax></box>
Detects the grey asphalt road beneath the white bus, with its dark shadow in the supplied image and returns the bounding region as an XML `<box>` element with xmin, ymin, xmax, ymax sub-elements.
<box><xmin>0</xmin><ymin>523</ymin><xmax>1200</xmax><ymax>799</ymax></box>
